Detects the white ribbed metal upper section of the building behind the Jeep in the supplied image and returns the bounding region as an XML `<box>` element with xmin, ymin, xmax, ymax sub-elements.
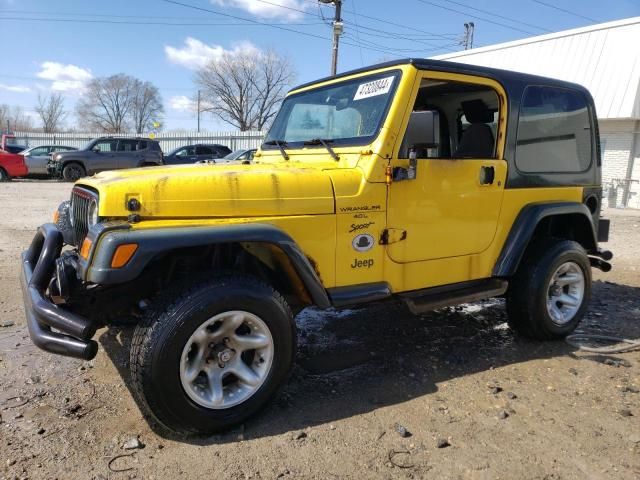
<box><xmin>434</xmin><ymin>17</ymin><xmax>640</xmax><ymax>119</ymax></box>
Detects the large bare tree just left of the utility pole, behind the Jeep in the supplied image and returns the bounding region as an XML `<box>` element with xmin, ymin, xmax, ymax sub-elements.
<box><xmin>196</xmin><ymin>51</ymin><xmax>295</xmax><ymax>131</ymax></box>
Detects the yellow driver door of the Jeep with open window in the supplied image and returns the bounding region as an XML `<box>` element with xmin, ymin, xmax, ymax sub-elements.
<box><xmin>387</xmin><ymin>72</ymin><xmax>507</xmax><ymax>268</ymax></box>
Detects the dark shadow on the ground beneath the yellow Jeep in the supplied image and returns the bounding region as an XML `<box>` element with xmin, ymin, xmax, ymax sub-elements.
<box><xmin>99</xmin><ymin>281</ymin><xmax>640</xmax><ymax>445</ymax></box>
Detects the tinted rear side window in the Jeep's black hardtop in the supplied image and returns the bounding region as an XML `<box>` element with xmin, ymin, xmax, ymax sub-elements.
<box><xmin>516</xmin><ymin>86</ymin><xmax>592</xmax><ymax>173</ymax></box>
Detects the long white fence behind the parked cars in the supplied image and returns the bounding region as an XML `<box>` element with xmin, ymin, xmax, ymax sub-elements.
<box><xmin>12</xmin><ymin>131</ymin><xmax>264</xmax><ymax>153</ymax></box>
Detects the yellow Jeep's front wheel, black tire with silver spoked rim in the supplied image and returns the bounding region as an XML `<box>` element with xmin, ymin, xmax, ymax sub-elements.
<box><xmin>130</xmin><ymin>276</ymin><xmax>296</xmax><ymax>435</ymax></box>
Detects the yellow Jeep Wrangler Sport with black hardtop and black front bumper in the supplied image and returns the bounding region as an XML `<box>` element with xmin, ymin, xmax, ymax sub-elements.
<box><xmin>22</xmin><ymin>59</ymin><xmax>612</xmax><ymax>433</ymax></box>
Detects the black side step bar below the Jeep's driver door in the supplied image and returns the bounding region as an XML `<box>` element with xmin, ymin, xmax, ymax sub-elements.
<box><xmin>399</xmin><ymin>278</ymin><xmax>509</xmax><ymax>314</ymax></box>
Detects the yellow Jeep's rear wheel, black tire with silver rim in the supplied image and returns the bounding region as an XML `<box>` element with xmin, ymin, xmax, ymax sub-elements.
<box><xmin>507</xmin><ymin>239</ymin><xmax>591</xmax><ymax>340</ymax></box>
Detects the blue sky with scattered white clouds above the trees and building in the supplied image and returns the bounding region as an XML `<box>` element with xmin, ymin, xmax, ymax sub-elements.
<box><xmin>0</xmin><ymin>0</ymin><xmax>640</xmax><ymax>131</ymax></box>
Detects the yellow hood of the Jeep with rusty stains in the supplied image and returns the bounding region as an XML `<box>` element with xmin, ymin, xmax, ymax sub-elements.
<box><xmin>77</xmin><ymin>164</ymin><xmax>335</xmax><ymax>218</ymax></box>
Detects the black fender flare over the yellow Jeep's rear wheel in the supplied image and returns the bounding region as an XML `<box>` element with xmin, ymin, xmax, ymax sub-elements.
<box><xmin>492</xmin><ymin>202</ymin><xmax>598</xmax><ymax>277</ymax></box>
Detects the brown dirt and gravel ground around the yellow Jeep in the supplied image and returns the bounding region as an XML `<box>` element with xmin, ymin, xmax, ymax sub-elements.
<box><xmin>0</xmin><ymin>181</ymin><xmax>640</xmax><ymax>480</ymax></box>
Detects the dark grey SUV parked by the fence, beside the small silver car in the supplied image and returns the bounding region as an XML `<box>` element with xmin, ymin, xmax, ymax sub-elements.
<box><xmin>47</xmin><ymin>137</ymin><xmax>164</xmax><ymax>182</ymax></box>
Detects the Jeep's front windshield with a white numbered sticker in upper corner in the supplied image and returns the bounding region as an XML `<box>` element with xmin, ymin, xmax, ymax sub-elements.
<box><xmin>263</xmin><ymin>71</ymin><xmax>400</xmax><ymax>148</ymax></box>
